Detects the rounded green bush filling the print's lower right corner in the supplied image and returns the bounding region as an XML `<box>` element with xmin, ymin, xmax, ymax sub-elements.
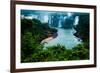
<box><xmin>70</xmin><ymin>44</ymin><xmax>89</xmax><ymax>60</ymax></box>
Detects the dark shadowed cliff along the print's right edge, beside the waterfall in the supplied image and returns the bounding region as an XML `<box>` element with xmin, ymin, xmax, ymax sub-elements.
<box><xmin>75</xmin><ymin>14</ymin><xmax>90</xmax><ymax>41</ymax></box>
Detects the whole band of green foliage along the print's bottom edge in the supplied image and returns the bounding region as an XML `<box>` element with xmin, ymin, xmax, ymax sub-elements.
<box><xmin>21</xmin><ymin>44</ymin><xmax>89</xmax><ymax>62</ymax></box>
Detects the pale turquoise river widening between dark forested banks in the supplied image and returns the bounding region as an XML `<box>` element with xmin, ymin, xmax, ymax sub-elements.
<box><xmin>44</xmin><ymin>28</ymin><xmax>82</xmax><ymax>49</ymax></box>
